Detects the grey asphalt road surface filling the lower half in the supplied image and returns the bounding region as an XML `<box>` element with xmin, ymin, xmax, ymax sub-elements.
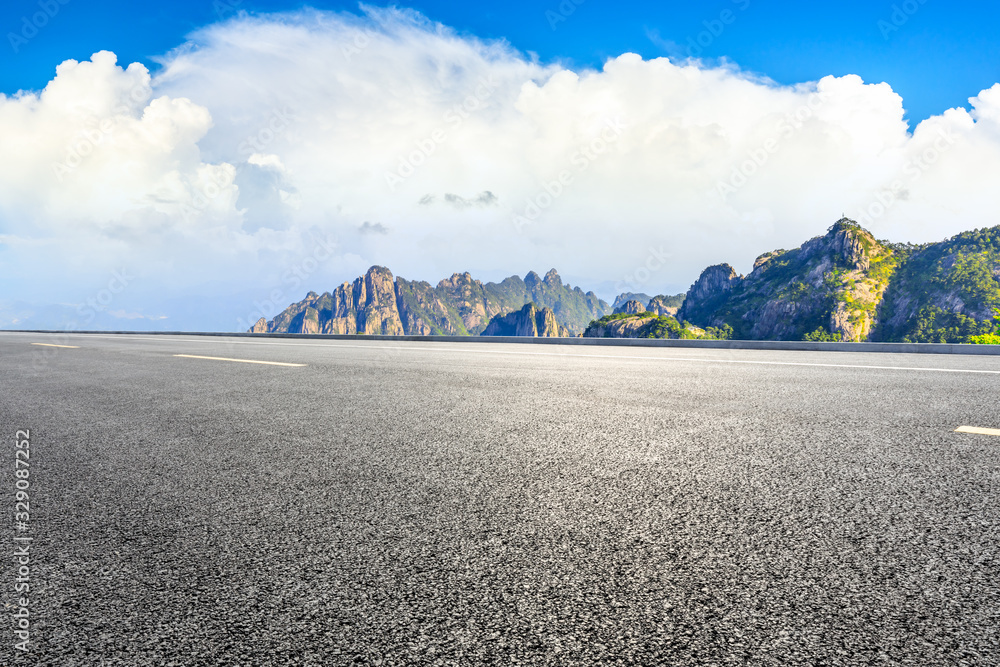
<box><xmin>0</xmin><ymin>333</ymin><xmax>1000</xmax><ymax>667</ymax></box>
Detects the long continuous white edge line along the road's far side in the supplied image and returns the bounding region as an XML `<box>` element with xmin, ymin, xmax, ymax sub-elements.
<box><xmin>7</xmin><ymin>334</ymin><xmax>1000</xmax><ymax>375</ymax></box>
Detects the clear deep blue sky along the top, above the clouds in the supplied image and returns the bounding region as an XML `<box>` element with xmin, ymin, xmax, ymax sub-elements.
<box><xmin>0</xmin><ymin>0</ymin><xmax>1000</xmax><ymax>125</ymax></box>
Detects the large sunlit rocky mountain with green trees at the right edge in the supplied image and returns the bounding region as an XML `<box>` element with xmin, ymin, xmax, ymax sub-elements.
<box><xmin>678</xmin><ymin>218</ymin><xmax>1000</xmax><ymax>343</ymax></box>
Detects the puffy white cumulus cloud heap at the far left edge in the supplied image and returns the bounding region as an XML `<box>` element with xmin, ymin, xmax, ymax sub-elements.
<box><xmin>0</xmin><ymin>51</ymin><xmax>235</xmax><ymax>230</ymax></box>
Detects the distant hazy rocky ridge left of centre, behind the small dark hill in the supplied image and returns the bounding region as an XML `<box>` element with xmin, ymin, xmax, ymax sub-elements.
<box><xmin>250</xmin><ymin>266</ymin><xmax>611</xmax><ymax>335</ymax></box>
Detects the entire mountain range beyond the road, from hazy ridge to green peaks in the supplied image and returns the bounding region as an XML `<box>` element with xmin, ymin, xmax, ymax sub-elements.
<box><xmin>251</xmin><ymin>218</ymin><xmax>1000</xmax><ymax>343</ymax></box>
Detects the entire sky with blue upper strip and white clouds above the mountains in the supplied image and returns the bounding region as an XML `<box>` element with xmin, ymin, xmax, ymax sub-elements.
<box><xmin>0</xmin><ymin>0</ymin><xmax>1000</xmax><ymax>331</ymax></box>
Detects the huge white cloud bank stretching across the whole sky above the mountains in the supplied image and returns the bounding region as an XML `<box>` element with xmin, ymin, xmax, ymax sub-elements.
<box><xmin>0</xmin><ymin>8</ymin><xmax>1000</xmax><ymax>328</ymax></box>
